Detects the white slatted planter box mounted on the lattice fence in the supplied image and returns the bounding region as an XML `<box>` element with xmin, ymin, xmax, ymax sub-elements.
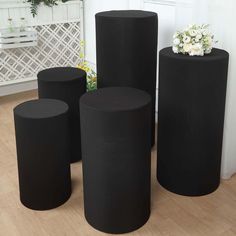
<box><xmin>0</xmin><ymin>28</ymin><xmax>37</xmax><ymax>49</ymax></box>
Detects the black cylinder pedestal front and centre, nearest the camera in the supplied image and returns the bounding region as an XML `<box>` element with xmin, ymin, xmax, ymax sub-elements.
<box><xmin>80</xmin><ymin>87</ymin><xmax>151</xmax><ymax>233</ymax></box>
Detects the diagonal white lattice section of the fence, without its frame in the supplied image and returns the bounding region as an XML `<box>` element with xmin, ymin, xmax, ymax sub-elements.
<box><xmin>0</xmin><ymin>22</ymin><xmax>81</xmax><ymax>85</ymax></box>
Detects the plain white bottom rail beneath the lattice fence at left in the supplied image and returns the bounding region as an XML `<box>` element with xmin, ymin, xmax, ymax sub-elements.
<box><xmin>0</xmin><ymin>78</ymin><xmax>38</xmax><ymax>96</ymax></box>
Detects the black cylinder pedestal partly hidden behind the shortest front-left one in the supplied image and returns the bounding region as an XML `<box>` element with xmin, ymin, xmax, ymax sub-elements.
<box><xmin>38</xmin><ymin>67</ymin><xmax>86</xmax><ymax>163</ymax></box>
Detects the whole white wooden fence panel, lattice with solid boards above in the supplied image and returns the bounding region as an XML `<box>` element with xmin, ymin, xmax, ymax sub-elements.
<box><xmin>0</xmin><ymin>0</ymin><xmax>83</xmax><ymax>96</ymax></box>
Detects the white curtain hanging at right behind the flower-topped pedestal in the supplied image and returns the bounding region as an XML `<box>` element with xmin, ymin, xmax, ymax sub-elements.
<box><xmin>176</xmin><ymin>0</ymin><xmax>236</xmax><ymax>179</ymax></box>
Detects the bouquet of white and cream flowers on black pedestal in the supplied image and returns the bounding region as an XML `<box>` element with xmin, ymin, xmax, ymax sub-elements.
<box><xmin>173</xmin><ymin>24</ymin><xmax>214</xmax><ymax>56</ymax></box>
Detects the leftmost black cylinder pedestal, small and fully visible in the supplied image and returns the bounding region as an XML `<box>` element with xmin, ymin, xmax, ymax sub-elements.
<box><xmin>14</xmin><ymin>99</ymin><xmax>71</xmax><ymax>210</ymax></box>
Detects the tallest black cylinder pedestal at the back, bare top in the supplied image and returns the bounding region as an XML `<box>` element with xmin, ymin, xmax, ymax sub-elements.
<box><xmin>96</xmin><ymin>10</ymin><xmax>158</xmax><ymax>146</ymax></box>
